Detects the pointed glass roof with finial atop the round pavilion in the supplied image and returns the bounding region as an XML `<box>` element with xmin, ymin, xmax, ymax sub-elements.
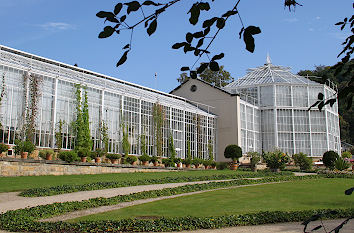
<box><xmin>225</xmin><ymin>55</ymin><xmax>318</xmax><ymax>90</ymax></box>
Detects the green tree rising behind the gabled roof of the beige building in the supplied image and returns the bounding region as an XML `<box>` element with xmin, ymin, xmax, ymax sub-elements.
<box><xmin>177</xmin><ymin>66</ymin><xmax>234</xmax><ymax>87</ymax></box>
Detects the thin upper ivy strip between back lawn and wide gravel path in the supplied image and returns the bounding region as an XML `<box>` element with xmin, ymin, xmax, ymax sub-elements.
<box><xmin>19</xmin><ymin>171</ymin><xmax>293</xmax><ymax>197</ymax></box>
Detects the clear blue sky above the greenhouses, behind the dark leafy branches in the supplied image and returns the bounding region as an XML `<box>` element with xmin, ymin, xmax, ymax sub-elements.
<box><xmin>0</xmin><ymin>0</ymin><xmax>353</xmax><ymax>92</ymax></box>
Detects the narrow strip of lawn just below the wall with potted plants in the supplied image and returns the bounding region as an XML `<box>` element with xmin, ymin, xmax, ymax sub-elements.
<box><xmin>0</xmin><ymin>170</ymin><xmax>246</xmax><ymax>192</ymax></box>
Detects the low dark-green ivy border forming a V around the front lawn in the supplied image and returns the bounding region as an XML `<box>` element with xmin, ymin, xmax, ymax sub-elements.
<box><xmin>0</xmin><ymin>176</ymin><xmax>346</xmax><ymax>232</ymax></box>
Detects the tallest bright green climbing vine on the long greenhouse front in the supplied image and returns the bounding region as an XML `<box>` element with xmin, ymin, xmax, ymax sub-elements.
<box><xmin>73</xmin><ymin>84</ymin><xmax>92</xmax><ymax>150</ymax></box>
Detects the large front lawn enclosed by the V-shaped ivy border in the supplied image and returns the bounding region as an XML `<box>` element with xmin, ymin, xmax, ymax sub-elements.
<box><xmin>71</xmin><ymin>179</ymin><xmax>354</xmax><ymax>222</ymax></box>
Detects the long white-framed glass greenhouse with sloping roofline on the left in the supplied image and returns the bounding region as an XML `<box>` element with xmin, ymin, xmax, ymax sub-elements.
<box><xmin>0</xmin><ymin>46</ymin><xmax>217</xmax><ymax>159</ymax></box>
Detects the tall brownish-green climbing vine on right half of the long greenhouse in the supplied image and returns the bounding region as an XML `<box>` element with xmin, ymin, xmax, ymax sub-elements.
<box><xmin>152</xmin><ymin>103</ymin><xmax>165</xmax><ymax>157</ymax></box>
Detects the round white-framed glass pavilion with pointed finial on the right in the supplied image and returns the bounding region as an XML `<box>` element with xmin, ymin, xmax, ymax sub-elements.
<box><xmin>224</xmin><ymin>56</ymin><xmax>341</xmax><ymax>157</ymax></box>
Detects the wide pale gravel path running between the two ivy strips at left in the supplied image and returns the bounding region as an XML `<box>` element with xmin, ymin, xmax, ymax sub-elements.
<box><xmin>0</xmin><ymin>180</ymin><xmax>241</xmax><ymax>213</ymax></box>
